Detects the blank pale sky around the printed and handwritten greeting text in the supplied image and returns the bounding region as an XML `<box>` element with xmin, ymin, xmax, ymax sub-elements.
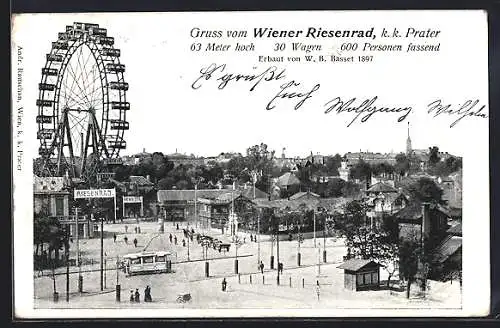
<box><xmin>13</xmin><ymin>12</ymin><xmax>488</xmax><ymax>156</ymax></box>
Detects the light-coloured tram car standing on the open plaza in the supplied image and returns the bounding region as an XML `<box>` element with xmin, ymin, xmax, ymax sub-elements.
<box><xmin>122</xmin><ymin>251</ymin><xmax>172</xmax><ymax>276</ymax></box>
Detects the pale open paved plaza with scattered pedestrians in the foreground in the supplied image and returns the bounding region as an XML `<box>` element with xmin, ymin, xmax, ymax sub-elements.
<box><xmin>34</xmin><ymin>221</ymin><xmax>460</xmax><ymax>309</ymax></box>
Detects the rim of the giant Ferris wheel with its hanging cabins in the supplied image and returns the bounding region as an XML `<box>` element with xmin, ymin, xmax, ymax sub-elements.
<box><xmin>37</xmin><ymin>23</ymin><xmax>128</xmax><ymax>178</ymax></box>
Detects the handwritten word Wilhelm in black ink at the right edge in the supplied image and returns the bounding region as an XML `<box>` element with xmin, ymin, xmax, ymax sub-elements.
<box><xmin>427</xmin><ymin>99</ymin><xmax>488</xmax><ymax>128</ymax></box>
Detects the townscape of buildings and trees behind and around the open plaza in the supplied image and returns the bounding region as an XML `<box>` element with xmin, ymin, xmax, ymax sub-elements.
<box><xmin>30</xmin><ymin>126</ymin><xmax>462</xmax><ymax>308</ymax></box>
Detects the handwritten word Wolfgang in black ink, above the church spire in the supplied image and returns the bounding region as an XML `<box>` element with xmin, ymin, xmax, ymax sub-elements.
<box><xmin>325</xmin><ymin>96</ymin><xmax>413</xmax><ymax>127</ymax></box>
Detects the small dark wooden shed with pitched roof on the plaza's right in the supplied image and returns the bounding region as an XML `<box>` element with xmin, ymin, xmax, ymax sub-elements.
<box><xmin>337</xmin><ymin>259</ymin><xmax>380</xmax><ymax>291</ymax></box>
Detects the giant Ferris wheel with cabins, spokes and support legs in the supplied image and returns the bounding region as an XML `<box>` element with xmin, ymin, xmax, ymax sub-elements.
<box><xmin>36</xmin><ymin>23</ymin><xmax>130</xmax><ymax>180</ymax></box>
